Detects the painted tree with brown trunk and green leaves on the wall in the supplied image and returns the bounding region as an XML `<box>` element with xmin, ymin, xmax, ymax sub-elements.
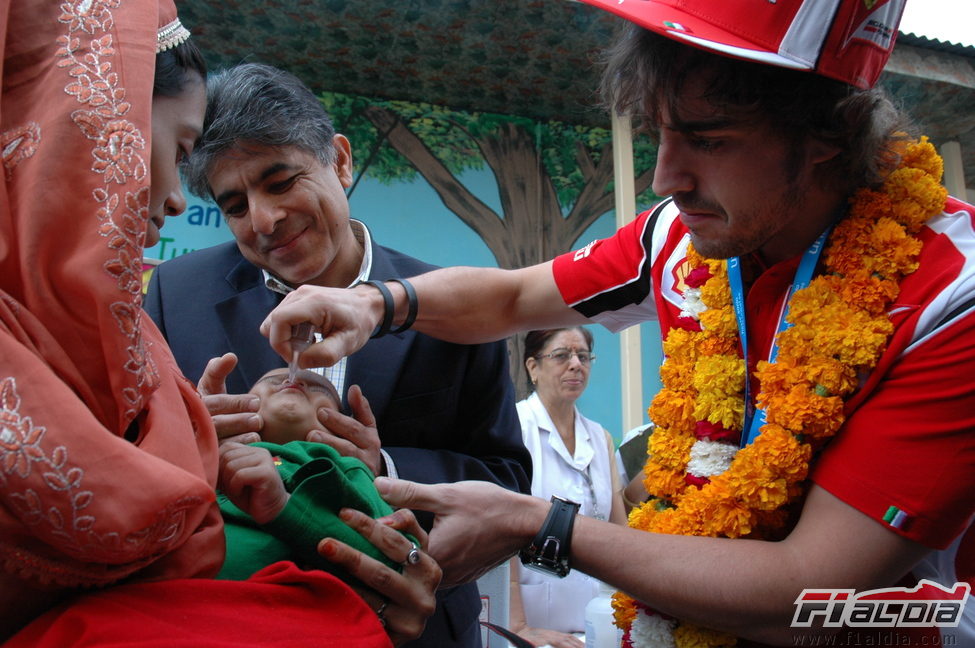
<box><xmin>321</xmin><ymin>93</ymin><xmax>656</xmax><ymax>398</ymax></box>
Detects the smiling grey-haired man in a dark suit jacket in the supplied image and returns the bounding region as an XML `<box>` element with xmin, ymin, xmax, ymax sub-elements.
<box><xmin>145</xmin><ymin>64</ymin><xmax>531</xmax><ymax>647</ymax></box>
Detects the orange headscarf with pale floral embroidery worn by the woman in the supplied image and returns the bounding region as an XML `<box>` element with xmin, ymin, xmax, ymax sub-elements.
<box><xmin>0</xmin><ymin>0</ymin><xmax>223</xmax><ymax>604</ymax></box>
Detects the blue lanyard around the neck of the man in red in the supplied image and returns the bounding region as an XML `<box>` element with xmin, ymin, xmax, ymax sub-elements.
<box><xmin>728</xmin><ymin>225</ymin><xmax>833</xmax><ymax>448</ymax></box>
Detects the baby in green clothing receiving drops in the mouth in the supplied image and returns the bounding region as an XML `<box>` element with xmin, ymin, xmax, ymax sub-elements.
<box><xmin>217</xmin><ymin>368</ymin><xmax>414</xmax><ymax>580</ymax></box>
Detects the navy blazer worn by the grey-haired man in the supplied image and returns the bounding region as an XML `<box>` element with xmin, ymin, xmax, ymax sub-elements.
<box><xmin>144</xmin><ymin>241</ymin><xmax>531</xmax><ymax>647</ymax></box>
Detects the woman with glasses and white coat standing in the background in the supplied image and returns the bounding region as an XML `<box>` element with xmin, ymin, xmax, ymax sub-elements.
<box><xmin>509</xmin><ymin>327</ymin><xmax>626</xmax><ymax>648</ymax></box>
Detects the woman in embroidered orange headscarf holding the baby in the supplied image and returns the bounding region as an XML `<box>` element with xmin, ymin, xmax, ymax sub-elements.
<box><xmin>0</xmin><ymin>0</ymin><xmax>439</xmax><ymax>646</ymax></box>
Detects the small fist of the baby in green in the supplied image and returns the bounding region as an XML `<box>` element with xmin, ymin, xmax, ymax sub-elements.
<box><xmin>219</xmin><ymin>441</ymin><xmax>291</xmax><ymax>524</ymax></box>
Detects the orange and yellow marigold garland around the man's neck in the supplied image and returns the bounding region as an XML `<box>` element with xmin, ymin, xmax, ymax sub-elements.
<box><xmin>613</xmin><ymin>138</ymin><xmax>947</xmax><ymax>648</ymax></box>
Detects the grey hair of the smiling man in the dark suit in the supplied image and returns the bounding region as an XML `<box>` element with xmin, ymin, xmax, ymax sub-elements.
<box><xmin>183</xmin><ymin>63</ymin><xmax>335</xmax><ymax>197</ymax></box>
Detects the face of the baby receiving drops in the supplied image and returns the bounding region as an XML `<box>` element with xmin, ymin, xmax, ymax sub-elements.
<box><xmin>250</xmin><ymin>368</ymin><xmax>339</xmax><ymax>444</ymax></box>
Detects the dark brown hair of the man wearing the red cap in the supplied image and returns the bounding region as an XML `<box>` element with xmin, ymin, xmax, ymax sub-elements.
<box><xmin>601</xmin><ymin>25</ymin><xmax>910</xmax><ymax>191</ymax></box>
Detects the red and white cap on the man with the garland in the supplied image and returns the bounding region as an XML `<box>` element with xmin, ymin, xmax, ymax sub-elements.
<box><xmin>582</xmin><ymin>0</ymin><xmax>919</xmax><ymax>88</ymax></box>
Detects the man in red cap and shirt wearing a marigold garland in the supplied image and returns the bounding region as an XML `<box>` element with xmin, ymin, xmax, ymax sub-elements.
<box><xmin>263</xmin><ymin>0</ymin><xmax>975</xmax><ymax>646</ymax></box>
